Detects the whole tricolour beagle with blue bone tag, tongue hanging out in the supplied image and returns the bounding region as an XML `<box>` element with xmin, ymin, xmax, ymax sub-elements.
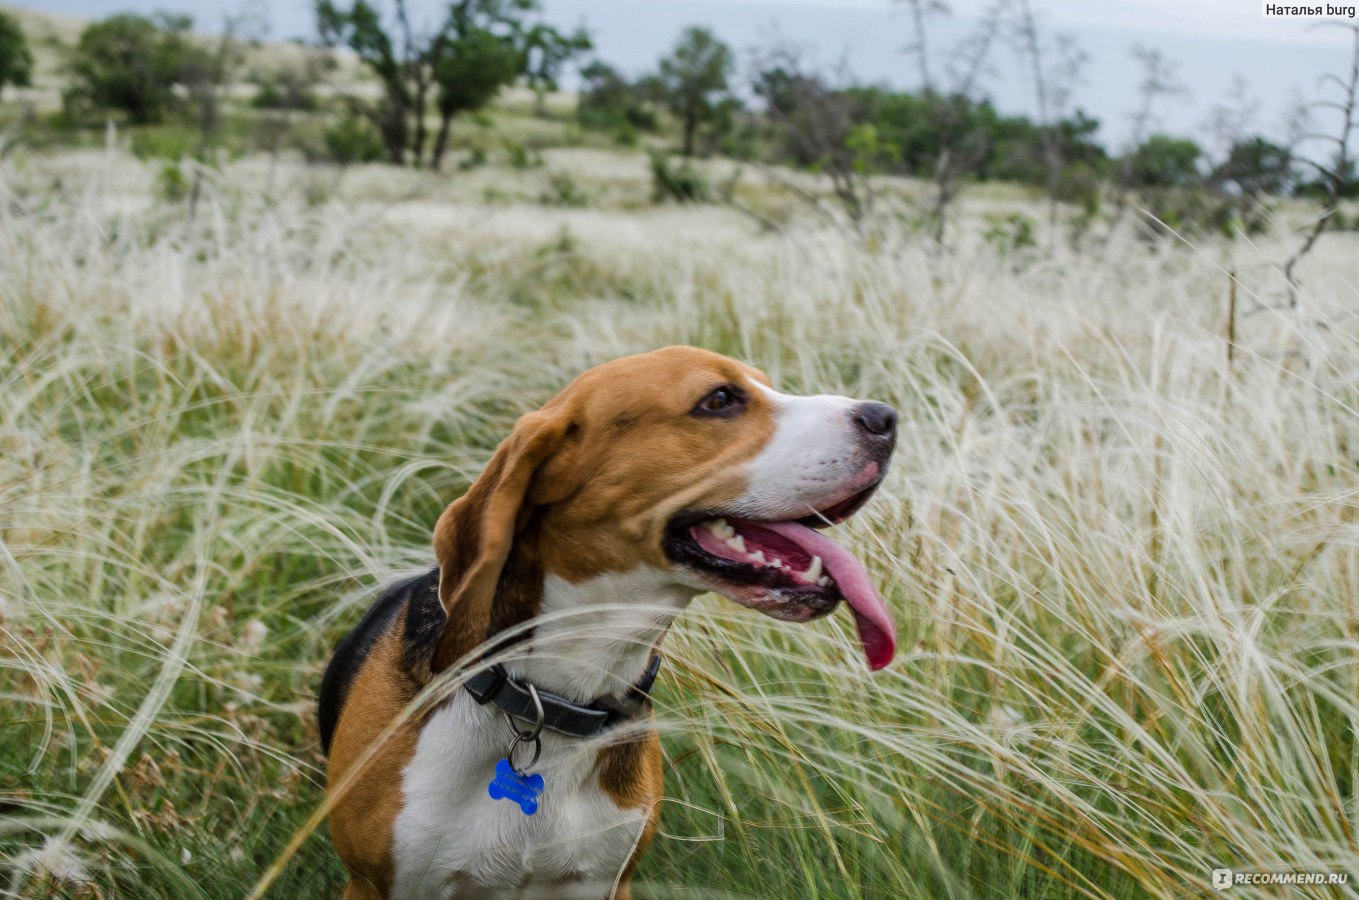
<box><xmin>319</xmin><ymin>347</ymin><xmax>897</xmax><ymax>900</ymax></box>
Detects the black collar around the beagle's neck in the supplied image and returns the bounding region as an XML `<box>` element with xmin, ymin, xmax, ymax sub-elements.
<box><xmin>463</xmin><ymin>655</ymin><xmax>660</xmax><ymax>737</ymax></box>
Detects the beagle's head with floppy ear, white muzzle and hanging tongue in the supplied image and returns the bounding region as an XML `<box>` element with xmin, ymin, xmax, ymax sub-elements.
<box><xmin>435</xmin><ymin>347</ymin><xmax>897</xmax><ymax>669</ymax></box>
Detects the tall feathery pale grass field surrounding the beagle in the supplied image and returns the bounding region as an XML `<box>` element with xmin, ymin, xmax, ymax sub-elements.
<box><xmin>0</xmin><ymin>144</ymin><xmax>1359</xmax><ymax>897</ymax></box>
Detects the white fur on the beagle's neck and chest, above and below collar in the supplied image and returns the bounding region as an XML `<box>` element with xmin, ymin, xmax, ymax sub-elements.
<box><xmin>393</xmin><ymin>567</ymin><xmax>693</xmax><ymax>900</ymax></box>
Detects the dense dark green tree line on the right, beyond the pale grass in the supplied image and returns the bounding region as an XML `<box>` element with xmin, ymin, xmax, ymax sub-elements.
<box><xmin>578</xmin><ymin>29</ymin><xmax>1359</xmax><ymax>241</ymax></box>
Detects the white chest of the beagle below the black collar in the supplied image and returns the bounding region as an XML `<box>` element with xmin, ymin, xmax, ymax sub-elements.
<box><xmin>393</xmin><ymin>695</ymin><xmax>646</xmax><ymax>899</ymax></box>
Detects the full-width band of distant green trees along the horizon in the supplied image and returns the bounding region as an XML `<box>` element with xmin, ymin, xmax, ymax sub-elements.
<box><xmin>0</xmin><ymin>0</ymin><xmax>1359</xmax><ymax>250</ymax></box>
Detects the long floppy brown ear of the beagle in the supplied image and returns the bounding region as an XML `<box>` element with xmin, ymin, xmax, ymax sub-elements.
<box><xmin>432</xmin><ymin>405</ymin><xmax>573</xmax><ymax>672</ymax></box>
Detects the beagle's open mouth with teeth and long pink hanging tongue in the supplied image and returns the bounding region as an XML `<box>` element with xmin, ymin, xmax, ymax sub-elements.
<box><xmin>665</xmin><ymin>481</ymin><xmax>897</xmax><ymax>670</ymax></box>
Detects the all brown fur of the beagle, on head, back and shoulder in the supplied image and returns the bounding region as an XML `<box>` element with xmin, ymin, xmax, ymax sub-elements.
<box><xmin>330</xmin><ymin>347</ymin><xmax>775</xmax><ymax>897</ymax></box>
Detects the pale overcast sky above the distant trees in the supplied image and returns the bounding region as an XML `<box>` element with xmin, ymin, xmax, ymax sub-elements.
<box><xmin>8</xmin><ymin>0</ymin><xmax>1352</xmax><ymax>147</ymax></box>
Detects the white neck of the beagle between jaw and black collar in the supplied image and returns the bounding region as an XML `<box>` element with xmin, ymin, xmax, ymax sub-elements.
<box><xmin>506</xmin><ymin>567</ymin><xmax>694</xmax><ymax>703</ymax></box>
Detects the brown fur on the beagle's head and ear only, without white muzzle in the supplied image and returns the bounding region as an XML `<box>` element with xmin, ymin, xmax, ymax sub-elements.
<box><xmin>434</xmin><ymin>347</ymin><xmax>773</xmax><ymax>672</ymax></box>
